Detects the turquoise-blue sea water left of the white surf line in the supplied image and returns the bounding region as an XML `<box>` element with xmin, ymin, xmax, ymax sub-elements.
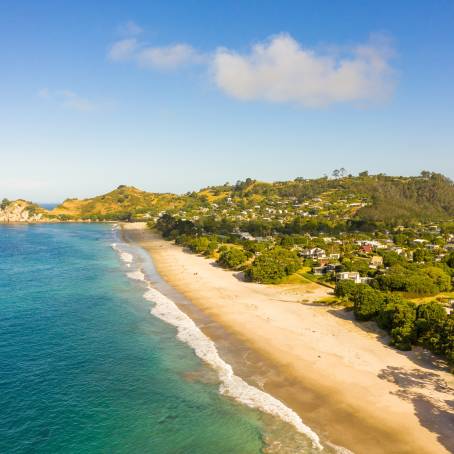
<box><xmin>0</xmin><ymin>224</ymin><xmax>263</xmax><ymax>454</ymax></box>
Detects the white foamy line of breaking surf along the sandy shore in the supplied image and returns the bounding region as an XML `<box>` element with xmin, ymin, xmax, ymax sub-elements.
<box><xmin>112</xmin><ymin>239</ymin><xmax>323</xmax><ymax>450</ymax></box>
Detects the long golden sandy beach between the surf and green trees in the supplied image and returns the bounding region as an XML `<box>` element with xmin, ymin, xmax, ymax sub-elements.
<box><xmin>124</xmin><ymin>223</ymin><xmax>454</xmax><ymax>454</ymax></box>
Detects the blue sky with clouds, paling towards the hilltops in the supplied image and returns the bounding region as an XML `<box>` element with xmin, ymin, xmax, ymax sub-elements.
<box><xmin>0</xmin><ymin>0</ymin><xmax>454</xmax><ymax>203</ymax></box>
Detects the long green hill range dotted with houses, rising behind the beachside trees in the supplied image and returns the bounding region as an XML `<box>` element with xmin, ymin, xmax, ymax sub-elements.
<box><xmin>4</xmin><ymin>171</ymin><xmax>454</xmax><ymax>227</ymax></box>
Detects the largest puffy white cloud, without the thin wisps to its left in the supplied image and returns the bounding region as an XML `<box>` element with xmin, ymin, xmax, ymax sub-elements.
<box><xmin>213</xmin><ymin>34</ymin><xmax>394</xmax><ymax>107</ymax></box>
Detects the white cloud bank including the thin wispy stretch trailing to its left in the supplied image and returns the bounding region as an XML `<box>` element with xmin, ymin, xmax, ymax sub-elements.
<box><xmin>108</xmin><ymin>33</ymin><xmax>395</xmax><ymax>108</ymax></box>
